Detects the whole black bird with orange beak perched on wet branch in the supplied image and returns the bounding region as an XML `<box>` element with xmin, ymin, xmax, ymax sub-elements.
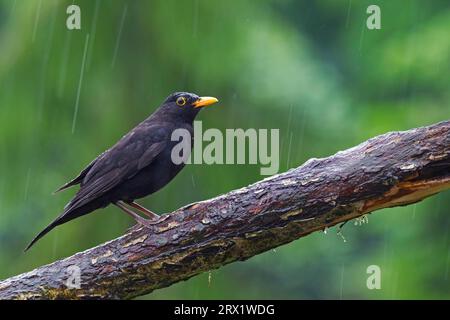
<box><xmin>25</xmin><ymin>92</ymin><xmax>218</xmax><ymax>251</ymax></box>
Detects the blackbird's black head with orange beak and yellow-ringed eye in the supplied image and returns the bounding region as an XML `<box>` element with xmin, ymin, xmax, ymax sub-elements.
<box><xmin>158</xmin><ymin>92</ymin><xmax>219</xmax><ymax>121</ymax></box>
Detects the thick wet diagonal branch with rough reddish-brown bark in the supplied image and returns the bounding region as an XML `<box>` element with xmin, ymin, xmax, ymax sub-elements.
<box><xmin>0</xmin><ymin>121</ymin><xmax>450</xmax><ymax>299</ymax></box>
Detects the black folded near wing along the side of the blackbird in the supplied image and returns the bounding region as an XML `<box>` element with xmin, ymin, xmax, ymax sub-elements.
<box><xmin>66</xmin><ymin>126</ymin><xmax>169</xmax><ymax>210</ymax></box>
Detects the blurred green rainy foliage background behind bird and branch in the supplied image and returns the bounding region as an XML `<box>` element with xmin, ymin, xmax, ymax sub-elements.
<box><xmin>0</xmin><ymin>0</ymin><xmax>450</xmax><ymax>299</ymax></box>
